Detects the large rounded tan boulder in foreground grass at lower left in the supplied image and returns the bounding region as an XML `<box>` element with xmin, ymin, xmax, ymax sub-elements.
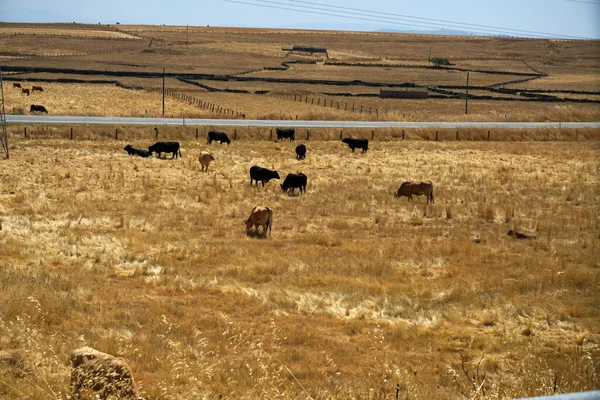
<box><xmin>71</xmin><ymin>347</ymin><xmax>140</xmax><ymax>399</ymax></box>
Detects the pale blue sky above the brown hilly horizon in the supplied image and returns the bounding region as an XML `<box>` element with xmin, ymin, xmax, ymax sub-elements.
<box><xmin>0</xmin><ymin>0</ymin><xmax>600</xmax><ymax>39</ymax></box>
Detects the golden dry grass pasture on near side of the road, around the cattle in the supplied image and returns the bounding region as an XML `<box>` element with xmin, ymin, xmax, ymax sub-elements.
<box><xmin>0</xmin><ymin>136</ymin><xmax>600</xmax><ymax>399</ymax></box>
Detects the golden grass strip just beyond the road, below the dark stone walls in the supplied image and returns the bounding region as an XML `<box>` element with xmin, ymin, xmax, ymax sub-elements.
<box><xmin>4</xmin><ymin>75</ymin><xmax>600</xmax><ymax>121</ymax></box>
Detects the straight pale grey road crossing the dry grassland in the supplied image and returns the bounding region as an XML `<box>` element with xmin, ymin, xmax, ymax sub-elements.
<box><xmin>6</xmin><ymin>115</ymin><xmax>600</xmax><ymax>129</ymax></box>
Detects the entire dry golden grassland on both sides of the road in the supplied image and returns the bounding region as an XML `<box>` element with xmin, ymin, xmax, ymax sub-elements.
<box><xmin>0</xmin><ymin>24</ymin><xmax>600</xmax><ymax>400</ymax></box>
